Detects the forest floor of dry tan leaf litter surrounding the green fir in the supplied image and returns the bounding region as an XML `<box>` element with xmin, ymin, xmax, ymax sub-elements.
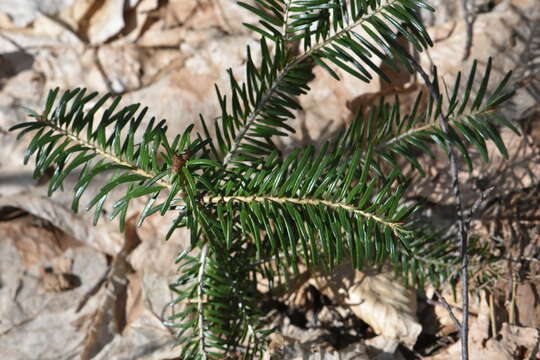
<box><xmin>0</xmin><ymin>0</ymin><xmax>540</xmax><ymax>360</ymax></box>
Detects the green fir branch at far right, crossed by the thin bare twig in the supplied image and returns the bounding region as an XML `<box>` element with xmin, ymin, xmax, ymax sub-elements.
<box><xmin>340</xmin><ymin>56</ymin><xmax>519</xmax><ymax>176</ymax></box>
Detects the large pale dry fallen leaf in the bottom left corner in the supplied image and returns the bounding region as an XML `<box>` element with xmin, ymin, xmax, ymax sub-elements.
<box><xmin>0</xmin><ymin>236</ymin><xmax>107</xmax><ymax>360</ymax></box>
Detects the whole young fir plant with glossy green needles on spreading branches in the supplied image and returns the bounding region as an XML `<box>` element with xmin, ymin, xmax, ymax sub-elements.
<box><xmin>12</xmin><ymin>0</ymin><xmax>517</xmax><ymax>359</ymax></box>
